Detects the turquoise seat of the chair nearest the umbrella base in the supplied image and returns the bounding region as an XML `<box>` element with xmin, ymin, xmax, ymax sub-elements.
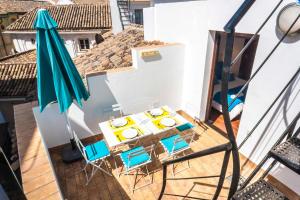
<box><xmin>85</xmin><ymin>140</ymin><xmax>110</xmax><ymax>161</ymax></box>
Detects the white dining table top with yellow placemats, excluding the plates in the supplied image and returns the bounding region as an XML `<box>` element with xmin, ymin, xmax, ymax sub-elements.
<box><xmin>99</xmin><ymin>106</ymin><xmax>188</xmax><ymax>148</ymax></box>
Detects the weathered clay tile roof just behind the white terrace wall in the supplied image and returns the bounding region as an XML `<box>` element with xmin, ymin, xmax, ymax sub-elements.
<box><xmin>74</xmin><ymin>25</ymin><xmax>163</xmax><ymax>77</ymax></box>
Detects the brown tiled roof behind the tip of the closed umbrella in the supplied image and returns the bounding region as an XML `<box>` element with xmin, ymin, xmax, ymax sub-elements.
<box><xmin>6</xmin><ymin>4</ymin><xmax>111</xmax><ymax>31</ymax></box>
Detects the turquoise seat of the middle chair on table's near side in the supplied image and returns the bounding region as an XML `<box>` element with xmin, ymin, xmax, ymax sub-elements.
<box><xmin>120</xmin><ymin>146</ymin><xmax>151</xmax><ymax>169</ymax></box>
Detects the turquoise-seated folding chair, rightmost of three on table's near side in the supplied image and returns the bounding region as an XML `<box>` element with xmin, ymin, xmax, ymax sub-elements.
<box><xmin>159</xmin><ymin>129</ymin><xmax>195</xmax><ymax>176</ymax></box>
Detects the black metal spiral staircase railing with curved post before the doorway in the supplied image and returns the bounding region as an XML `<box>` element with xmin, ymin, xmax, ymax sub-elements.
<box><xmin>159</xmin><ymin>0</ymin><xmax>300</xmax><ymax>199</ymax></box>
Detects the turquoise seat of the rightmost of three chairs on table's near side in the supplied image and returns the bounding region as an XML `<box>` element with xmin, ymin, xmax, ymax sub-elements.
<box><xmin>160</xmin><ymin>134</ymin><xmax>189</xmax><ymax>154</ymax></box>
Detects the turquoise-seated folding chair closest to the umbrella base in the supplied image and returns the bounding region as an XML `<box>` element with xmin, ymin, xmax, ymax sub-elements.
<box><xmin>74</xmin><ymin>133</ymin><xmax>112</xmax><ymax>185</ymax></box>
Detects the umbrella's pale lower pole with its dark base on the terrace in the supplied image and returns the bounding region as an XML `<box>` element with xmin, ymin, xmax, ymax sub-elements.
<box><xmin>62</xmin><ymin>109</ymin><xmax>83</xmax><ymax>163</ymax></box>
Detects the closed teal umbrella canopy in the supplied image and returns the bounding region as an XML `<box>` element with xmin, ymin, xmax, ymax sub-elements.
<box><xmin>34</xmin><ymin>9</ymin><xmax>89</xmax><ymax>112</ymax></box>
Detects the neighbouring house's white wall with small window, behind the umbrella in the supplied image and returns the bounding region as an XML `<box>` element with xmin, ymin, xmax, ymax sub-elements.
<box><xmin>11</xmin><ymin>33</ymin><xmax>95</xmax><ymax>58</ymax></box>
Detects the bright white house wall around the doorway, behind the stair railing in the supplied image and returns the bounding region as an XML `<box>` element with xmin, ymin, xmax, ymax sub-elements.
<box><xmin>144</xmin><ymin>0</ymin><xmax>300</xmax><ymax>194</ymax></box>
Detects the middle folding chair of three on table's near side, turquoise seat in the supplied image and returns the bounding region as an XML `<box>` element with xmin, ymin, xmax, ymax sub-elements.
<box><xmin>115</xmin><ymin>145</ymin><xmax>154</xmax><ymax>193</ymax></box>
